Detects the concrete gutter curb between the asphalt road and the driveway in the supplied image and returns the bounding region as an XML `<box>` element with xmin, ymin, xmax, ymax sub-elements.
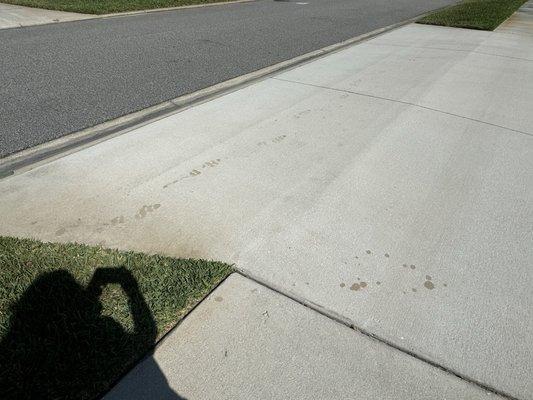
<box><xmin>0</xmin><ymin>0</ymin><xmax>462</xmax><ymax>179</ymax></box>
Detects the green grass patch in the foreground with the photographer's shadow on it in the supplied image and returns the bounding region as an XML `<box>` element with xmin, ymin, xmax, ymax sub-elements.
<box><xmin>0</xmin><ymin>236</ymin><xmax>232</xmax><ymax>400</ymax></box>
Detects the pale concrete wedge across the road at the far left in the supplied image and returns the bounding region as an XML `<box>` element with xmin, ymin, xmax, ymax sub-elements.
<box><xmin>0</xmin><ymin>3</ymin><xmax>92</xmax><ymax>29</ymax></box>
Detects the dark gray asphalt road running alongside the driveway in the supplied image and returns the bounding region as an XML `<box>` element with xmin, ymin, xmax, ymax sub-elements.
<box><xmin>0</xmin><ymin>0</ymin><xmax>455</xmax><ymax>157</ymax></box>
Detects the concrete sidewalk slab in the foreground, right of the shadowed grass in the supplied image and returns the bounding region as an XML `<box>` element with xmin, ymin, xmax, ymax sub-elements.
<box><xmin>104</xmin><ymin>274</ymin><xmax>499</xmax><ymax>400</ymax></box>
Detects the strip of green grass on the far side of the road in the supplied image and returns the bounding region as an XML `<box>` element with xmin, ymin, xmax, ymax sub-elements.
<box><xmin>2</xmin><ymin>0</ymin><xmax>233</xmax><ymax>14</ymax></box>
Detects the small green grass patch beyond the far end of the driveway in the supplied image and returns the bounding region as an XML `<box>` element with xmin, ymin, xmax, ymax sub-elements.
<box><xmin>418</xmin><ymin>0</ymin><xmax>526</xmax><ymax>31</ymax></box>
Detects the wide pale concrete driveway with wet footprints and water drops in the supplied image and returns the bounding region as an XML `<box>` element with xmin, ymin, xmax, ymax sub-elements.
<box><xmin>0</xmin><ymin>21</ymin><xmax>533</xmax><ymax>400</ymax></box>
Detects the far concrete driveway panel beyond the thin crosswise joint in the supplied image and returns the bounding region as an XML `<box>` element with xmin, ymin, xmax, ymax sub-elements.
<box><xmin>278</xmin><ymin>24</ymin><xmax>533</xmax><ymax>134</ymax></box>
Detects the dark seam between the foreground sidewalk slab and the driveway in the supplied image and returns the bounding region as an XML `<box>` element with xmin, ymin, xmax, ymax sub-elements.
<box><xmin>234</xmin><ymin>266</ymin><xmax>520</xmax><ymax>400</ymax></box>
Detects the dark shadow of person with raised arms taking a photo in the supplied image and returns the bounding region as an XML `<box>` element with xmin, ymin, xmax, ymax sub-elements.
<box><xmin>0</xmin><ymin>267</ymin><xmax>182</xmax><ymax>400</ymax></box>
